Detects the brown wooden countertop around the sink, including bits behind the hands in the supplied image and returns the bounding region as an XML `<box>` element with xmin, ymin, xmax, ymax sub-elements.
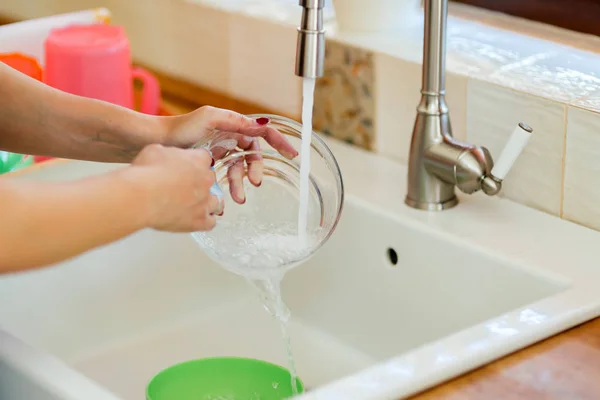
<box><xmin>159</xmin><ymin>90</ymin><xmax>600</xmax><ymax>400</ymax></box>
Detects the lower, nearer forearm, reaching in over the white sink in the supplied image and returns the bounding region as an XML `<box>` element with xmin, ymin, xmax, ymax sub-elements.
<box><xmin>0</xmin><ymin>167</ymin><xmax>150</xmax><ymax>274</ymax></box>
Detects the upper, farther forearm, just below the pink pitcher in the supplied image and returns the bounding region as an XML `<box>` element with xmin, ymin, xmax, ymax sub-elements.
<box><xmin>0</xmin><ymin>63</ymin><xmax>169</xmax><ymax>162</ymax></box>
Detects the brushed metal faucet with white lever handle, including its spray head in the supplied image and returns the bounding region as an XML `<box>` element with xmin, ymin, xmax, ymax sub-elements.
<box><xmin>296</xmin><ymin>0</ymin><xmax>533</xmax><ymax>211</ymax></box>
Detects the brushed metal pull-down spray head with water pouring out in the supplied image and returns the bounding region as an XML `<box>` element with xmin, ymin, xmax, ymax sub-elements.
<box><xmin>296</xmin><ymin>0</ymin><xmax>325</xmax><ymax>78</ymax></box>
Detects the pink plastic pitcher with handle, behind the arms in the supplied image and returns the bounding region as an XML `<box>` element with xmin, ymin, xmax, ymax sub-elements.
<box><xmin>44</xmin><ymin>24</ymin><xmax>160</xmax><ymax>115</ymax></box>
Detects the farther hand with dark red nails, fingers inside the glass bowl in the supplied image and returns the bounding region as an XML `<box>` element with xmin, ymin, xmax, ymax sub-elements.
<box><xmin>166</xmin><ymin>106</ymin><xmax>298</xmax><ymax>204</ymax></box>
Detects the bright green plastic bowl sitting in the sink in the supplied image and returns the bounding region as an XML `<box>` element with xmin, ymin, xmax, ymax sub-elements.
<box><xmin>146</xmin><ymin>357</ymin><xmax>304</xmax><ymax>400</ymax></box>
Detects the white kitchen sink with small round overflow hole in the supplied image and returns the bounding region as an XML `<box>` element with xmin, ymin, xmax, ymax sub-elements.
<box><xmin>0</xmin><ymin>138</ymin><xmax>600</xmax><ymax>400</ymax></box>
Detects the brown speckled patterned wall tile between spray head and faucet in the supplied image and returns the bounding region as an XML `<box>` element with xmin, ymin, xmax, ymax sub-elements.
<box><xmin>313</xmin><ymin>41</ymin><xmax>375</xmax><ymax>150</ymax></box>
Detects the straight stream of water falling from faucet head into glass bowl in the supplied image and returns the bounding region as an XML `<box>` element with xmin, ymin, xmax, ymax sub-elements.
<box><xmin>298</xmin><ymin>78</ymin><xmax>315</xmax><ymax>245</ymax></box>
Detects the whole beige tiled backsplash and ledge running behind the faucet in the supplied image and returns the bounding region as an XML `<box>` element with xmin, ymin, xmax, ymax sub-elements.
<box><xmin>0</xmin><ymin>0</ymin><xmax>600</xmax><ymax>230</ymax></box>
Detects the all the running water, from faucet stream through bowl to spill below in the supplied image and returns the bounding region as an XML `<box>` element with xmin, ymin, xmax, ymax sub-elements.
<box><xmin>192</xmin><ymin>78</ymin><xmax>316</xmax><ymax>395</ymax></box>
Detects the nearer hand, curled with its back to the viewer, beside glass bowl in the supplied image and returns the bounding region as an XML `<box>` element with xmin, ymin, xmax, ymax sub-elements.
<box><xmin>131</xmin><ymin>144</ymin><xmax>222</xmax><ymax>232</ymax></box>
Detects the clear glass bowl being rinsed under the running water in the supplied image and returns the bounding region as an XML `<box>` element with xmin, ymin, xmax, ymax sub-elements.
<box><xmin>192</xmin><ymin>114</ymin><xmax>344</xmax><ymax>279</ymax></box>
